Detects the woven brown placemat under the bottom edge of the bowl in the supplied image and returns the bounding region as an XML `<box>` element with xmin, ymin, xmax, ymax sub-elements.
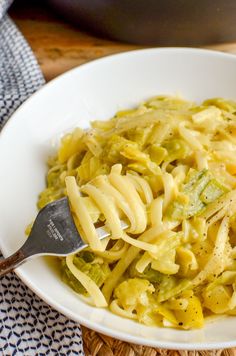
<box><xmin>82</xmin><ymin>326</ymin><xmax>236</xmax><ymax>356</ymax></box>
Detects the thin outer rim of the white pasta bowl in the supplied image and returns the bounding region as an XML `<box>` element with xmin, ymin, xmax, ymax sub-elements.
<box><xmin>0</xmin><ymin>47</ymin><xmax>236</xmax><ymax>350</ymax></box>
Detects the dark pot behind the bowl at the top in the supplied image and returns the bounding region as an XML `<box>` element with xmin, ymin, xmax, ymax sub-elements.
<box><xmin>48</xmin><ymin>0</ymin><xmax>236</xmax><ymax>46</ymax></box>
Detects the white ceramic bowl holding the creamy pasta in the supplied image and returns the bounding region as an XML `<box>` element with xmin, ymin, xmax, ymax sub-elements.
<box><xmin>0</xmin><ymin>48</ymin><xmax>236</xmax><ymax>349</ymax></box>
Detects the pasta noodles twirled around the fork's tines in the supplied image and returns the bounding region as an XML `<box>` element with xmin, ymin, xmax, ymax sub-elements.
<box><xmin>66</xmin><ymin>166</ymin><xmax>157</xmax><ymax>253</ymax></box>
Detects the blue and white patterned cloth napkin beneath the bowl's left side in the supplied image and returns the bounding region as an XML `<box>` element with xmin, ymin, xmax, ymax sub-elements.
<box><xmin>0</xmin><ymin>0</ymin><xmax>84</xmax><ymax>356</ymax></box>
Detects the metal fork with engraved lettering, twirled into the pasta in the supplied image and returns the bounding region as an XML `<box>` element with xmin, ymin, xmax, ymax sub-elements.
<box><xmin>0</xmin><ymin>197</ymin><xmax>128</xmax><ymax>277</ymax></box>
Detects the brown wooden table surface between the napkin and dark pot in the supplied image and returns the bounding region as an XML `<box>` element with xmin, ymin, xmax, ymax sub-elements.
<box><xmin>10</xmin><ymin>0</ymin><xmax>236</xmax><ymax>81</ymax></box>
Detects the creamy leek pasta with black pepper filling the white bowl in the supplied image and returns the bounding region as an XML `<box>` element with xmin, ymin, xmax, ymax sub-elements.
<box><xmin>38</xmin><ymin>96</ymin><xmax>236</xmax><ymax>329</ymax></box>
